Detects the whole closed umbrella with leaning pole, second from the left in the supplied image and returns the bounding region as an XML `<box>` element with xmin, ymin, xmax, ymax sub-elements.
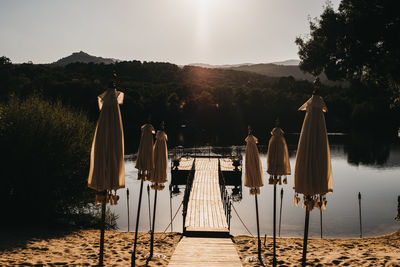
<box><xmin>131</xmin><ymin>120</ymin><xmax>155</xmax><ymax>267</ymax></box>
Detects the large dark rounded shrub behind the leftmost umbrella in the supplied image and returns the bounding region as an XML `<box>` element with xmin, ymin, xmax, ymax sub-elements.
<box><xmin>0</xmin><ymin>95</ymin><xmax>94</xmax><ymax>227</ymax></box>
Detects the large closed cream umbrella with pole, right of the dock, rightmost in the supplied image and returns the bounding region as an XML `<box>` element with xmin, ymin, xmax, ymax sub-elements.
<box><xmin>294</xmin><ymin>79</ymin><xmax>333</xmax><ymax>266</ymax></box>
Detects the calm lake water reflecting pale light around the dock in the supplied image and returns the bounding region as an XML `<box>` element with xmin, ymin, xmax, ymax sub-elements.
<box><xmin>111</xmin><ymin>135</ymin><xmax>400</xmax><ymax>237</ymax></box>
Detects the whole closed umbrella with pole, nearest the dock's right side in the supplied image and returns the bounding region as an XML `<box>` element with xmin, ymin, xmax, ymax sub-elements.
<box><xmin>244</xmin><ymin>126</ymin><xmax>264</xmax><ymax>264</ymax></box>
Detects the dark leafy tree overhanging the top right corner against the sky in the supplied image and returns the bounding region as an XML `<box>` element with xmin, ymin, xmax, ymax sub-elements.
<box><xmin>296</xmin><ymin>0</ymin><xmax>400</xmax><ymax>103</ymax></box>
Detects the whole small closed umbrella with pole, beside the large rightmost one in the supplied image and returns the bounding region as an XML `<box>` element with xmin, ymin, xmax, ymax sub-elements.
<box><xmin>267</xmin><ymin>120</ymin><xmax>291</xmax><ymax>266</ymax></box>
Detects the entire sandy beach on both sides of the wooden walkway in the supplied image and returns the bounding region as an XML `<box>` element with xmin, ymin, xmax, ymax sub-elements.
<box><xmin>0</xmin><ymin>230</ymin><xmax>400</xmax><ymax>266</ymax></box>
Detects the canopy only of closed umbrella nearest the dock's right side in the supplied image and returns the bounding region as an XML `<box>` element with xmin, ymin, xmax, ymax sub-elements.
<box><xmin>244</xmin><ymin>134</ymin><xmax>264</xmax><ymax>194</ymax></box>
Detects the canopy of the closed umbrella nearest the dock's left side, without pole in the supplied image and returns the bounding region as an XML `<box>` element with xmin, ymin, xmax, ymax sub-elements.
<box><xmin>150</xmin><ymin>130</ymin><xmax>168</xmax><ymax>190</ymax></box>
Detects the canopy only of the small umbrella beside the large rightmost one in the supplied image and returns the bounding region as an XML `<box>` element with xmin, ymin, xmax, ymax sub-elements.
<box><xmin>267</xmin><ymin>127</ymin><xmax>291</xmax><ymax>180</ymax></box>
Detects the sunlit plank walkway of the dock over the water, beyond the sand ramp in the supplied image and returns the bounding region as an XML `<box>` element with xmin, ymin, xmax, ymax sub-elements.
<box><xmin>185</xmin><ymin>158</ymin><xmax>229</xmax><ymax>233</ymax></box>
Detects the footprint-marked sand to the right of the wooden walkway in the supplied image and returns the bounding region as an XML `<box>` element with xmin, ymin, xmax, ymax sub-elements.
<box><xmin>233</xmin><ymin>231</ymin><xmax>400</xmax><ymax>266</ymax></box>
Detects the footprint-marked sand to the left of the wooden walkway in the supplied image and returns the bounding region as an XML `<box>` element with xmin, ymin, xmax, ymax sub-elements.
<box><xmin>0</xmin><ymin>230</ymin><xmax>181</xmax><ymax>266</ymax></box>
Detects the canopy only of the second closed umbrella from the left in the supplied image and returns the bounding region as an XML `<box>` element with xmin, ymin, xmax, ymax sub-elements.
<box><xmin>135</xmin><ymin>123</ymin><xmax>155</xmax><ymax>179</ymax></box>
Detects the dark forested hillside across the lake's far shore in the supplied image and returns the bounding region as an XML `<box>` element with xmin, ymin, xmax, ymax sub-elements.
<box><xmin>0</xmin><ymin>58</ymin><xmax>396</xmax><ymax>153</ymax></box>
